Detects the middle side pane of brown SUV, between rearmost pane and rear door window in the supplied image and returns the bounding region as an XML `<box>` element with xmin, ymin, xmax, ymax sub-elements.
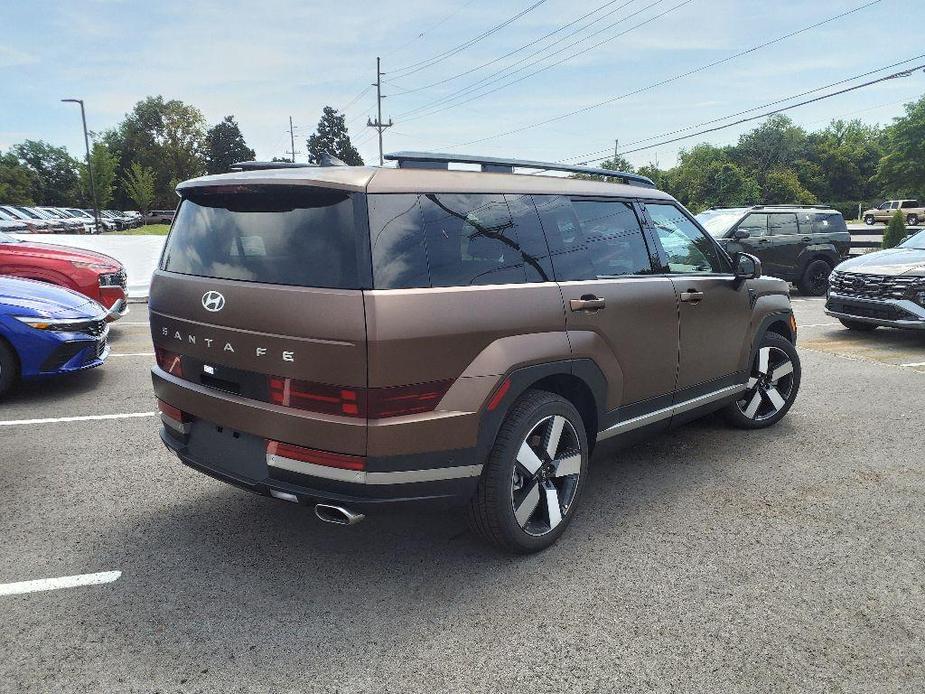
<box><xmin>421</xmin><ymin>193</ymin><xmax>526</xmax><ymax>287</ymax></box>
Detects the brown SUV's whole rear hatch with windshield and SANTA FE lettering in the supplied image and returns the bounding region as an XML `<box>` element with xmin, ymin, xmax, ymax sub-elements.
<box><xmin>149</xmin><ymin>181</ymin><xmax>370</xmax><ymax>454</ymax></box>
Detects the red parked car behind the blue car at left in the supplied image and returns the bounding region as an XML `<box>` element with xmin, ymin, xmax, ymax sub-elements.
<box><xmin>0</xmin><ymin>232</ymin><xmax>128</xmax><ymax>321</ymax></box>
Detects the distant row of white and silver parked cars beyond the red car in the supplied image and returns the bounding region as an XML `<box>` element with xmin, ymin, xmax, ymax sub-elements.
<box><xmin>0</xmin><ymin>205</ymin><xmax>144</xmax><ymax>234</ymax></box>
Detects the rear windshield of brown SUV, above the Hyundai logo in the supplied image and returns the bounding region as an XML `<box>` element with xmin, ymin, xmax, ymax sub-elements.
<box><xmin>161</xmin><ymin>186</ymin><xmax>360</xmax><ymax>289</ymax></box>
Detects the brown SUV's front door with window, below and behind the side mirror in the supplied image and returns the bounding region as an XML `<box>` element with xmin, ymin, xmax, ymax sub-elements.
<box><xmin>644</xmin><ymin>201</ymin><xmax>751</xmax><ymax>402</ymax></box>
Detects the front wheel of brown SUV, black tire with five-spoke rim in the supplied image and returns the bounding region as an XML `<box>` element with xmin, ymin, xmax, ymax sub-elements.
<box><xmin>724</xmin><ymin>332</ymin><xmax>802</xmax><ymax>429</ymax></box>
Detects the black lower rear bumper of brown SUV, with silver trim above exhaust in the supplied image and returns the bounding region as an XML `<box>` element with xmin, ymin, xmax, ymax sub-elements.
<box><xmin>160</xmin><ymin>423</ymin><xmax>481</xmax><ymax>511</ymax></box>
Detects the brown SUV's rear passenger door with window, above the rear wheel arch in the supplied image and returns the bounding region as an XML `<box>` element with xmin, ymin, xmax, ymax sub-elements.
<box><xmin>534</xmin><ymin>196</ymin><xmax>678</xmax><ymax>418</ymax></box>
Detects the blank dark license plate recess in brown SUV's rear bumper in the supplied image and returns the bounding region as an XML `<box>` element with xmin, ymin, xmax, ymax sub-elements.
<box><xmin>186</xmin><ymin>420</ymin><xmax>267</xmax><ymax>482</ymax></box>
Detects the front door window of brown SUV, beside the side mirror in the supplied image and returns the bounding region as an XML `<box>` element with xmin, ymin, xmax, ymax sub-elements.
<box><xmin>646</xmin><ymin>203</ymin><xmax>729</xmax><ymax>274</ymax></box>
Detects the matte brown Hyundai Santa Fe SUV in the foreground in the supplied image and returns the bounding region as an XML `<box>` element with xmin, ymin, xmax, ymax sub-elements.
<box><xmin>150</xmin><ymin>153</ymin><xmax>800</xmax><ymax>552</ymax></box>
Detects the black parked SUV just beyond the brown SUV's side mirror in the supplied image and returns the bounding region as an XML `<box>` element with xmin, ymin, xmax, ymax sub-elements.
<box><xmin>697</xmin><ymin>205</ymin><xmax>851</xmax><ymax>296</ymax></box>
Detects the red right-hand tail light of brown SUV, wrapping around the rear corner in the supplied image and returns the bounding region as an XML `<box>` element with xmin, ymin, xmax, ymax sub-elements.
<box><xmin>269</xmin><ymin>376</ymin><xmax>453</xmax><ymax>419</ymax></box>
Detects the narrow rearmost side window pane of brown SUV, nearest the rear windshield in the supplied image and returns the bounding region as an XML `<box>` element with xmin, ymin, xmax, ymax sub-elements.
<box><xmin>367</xmin><ymin>195</ymin><xmax>430</xmax><ymax>289</ymax></box>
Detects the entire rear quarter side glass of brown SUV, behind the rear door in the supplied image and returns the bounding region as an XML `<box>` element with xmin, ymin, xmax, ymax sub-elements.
<box><xmin>368</xmin><ymin>193</ymin><xmax>552</xmax><ymax>289</ymax></box>
